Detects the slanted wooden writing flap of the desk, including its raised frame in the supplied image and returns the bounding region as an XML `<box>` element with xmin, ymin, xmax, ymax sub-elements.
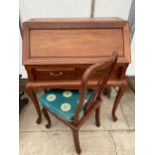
<box><xmin>23</xmin><ymin>20</ymin><xmax>130</xmax><ymax>64</ymax></box>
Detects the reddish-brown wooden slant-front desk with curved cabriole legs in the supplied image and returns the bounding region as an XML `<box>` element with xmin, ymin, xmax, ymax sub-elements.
<box><xmin>23</xmin><ymin>18</ymin><xmax>130</xmax><ymax>123</ymax></box>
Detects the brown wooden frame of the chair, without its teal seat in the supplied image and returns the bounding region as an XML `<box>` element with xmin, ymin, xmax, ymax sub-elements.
<box><xmin>42</xmin><ymin>52</ymin><xmax>118</xmax><ymax>154</ymax></box>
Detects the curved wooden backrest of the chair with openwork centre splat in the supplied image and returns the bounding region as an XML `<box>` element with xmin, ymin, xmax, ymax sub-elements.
<box><xmin>73</xmin><ymin>52</ymin><xmax>118</xmax><ymax>124</ymax></box>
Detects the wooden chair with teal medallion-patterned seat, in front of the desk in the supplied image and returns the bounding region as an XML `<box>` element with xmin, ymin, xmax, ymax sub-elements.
<box><xmin>39</xmin><ymin>52</ymin><xmax>118</xmax><ymax>154</ymax></box>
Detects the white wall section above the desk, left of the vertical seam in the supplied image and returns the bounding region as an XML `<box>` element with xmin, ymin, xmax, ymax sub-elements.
<box><xmin>20</xmin><ymin>0</ymin><xmax>91</xmax><ymax>21</ymax></box>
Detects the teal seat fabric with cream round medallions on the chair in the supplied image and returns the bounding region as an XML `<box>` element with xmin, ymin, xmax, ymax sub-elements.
<box><xmin>39</xmin><ymin>89</ymin><xmax>93</xmax><ymax>122</ymax></box>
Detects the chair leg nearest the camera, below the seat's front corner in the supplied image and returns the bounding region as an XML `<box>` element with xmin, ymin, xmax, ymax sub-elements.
<box><xmin>72</xmin><ymin>129</ymin><xmax>81</xmax><ymax>154</ymax></box>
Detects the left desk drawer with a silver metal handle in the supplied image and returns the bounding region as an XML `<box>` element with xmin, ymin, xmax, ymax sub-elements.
<box><xmin>33</xmin><ymin>68</ymin><xmax>75</xmax><ymax>81</ymax></box>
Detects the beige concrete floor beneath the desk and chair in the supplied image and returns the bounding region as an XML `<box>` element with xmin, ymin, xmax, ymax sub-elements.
<box><xmin>20</xmin><ymin>90</ymin><xmax>135</xmax><ymax>155</ymax></box>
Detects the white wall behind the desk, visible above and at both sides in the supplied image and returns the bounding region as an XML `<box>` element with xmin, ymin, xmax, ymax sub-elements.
<box><xmin>19</xmin><ymin>0</ymin><xmax>135</xmax><ymax>78</ymax></box>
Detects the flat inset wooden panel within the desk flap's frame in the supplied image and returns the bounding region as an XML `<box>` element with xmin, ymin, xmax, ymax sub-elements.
<box><xmin>30</xmin><ymin>29</ymin><xmax>123</xmax><ymax>59</ymax></box>
